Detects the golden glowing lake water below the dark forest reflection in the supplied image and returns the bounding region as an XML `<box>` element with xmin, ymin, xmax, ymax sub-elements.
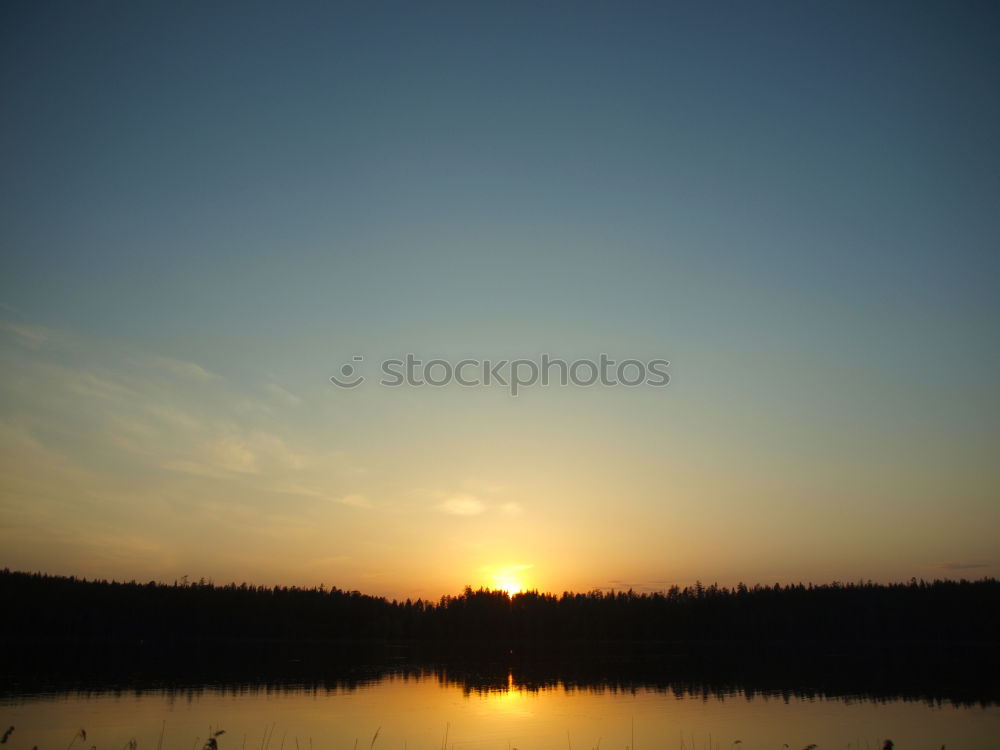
<box><xmin>0</xmin><ymin>674</ymin><xmax>1000</xmax><ymax>750</ymax></box>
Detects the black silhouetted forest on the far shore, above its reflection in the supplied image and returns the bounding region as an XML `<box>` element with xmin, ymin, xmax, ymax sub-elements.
<box><xmin>0</xmin><ymin>570</ymin><xmax>1000</xmax><ymax>643</ymax></box>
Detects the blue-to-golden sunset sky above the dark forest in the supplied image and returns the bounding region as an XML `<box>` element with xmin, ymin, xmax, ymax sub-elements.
<box><xmin>0</xmin><ymin>0</ymin><xmax>1000</xmax><ymax>598</ymax></box>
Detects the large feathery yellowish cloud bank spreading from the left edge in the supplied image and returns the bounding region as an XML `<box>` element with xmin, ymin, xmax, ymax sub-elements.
<box><xmin>0</xmin><ymin>314</ymin><xmax>391</xmax><ymax>576</ymax></box>
